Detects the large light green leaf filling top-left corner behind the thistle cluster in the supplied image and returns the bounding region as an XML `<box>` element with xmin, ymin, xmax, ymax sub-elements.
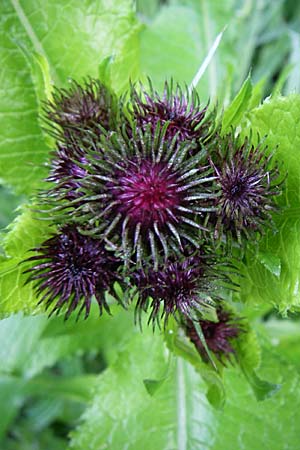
<box><xmin>0</xmin><ymin>0</ymin><xmax>138</xmax><ymax>193</ymax></box>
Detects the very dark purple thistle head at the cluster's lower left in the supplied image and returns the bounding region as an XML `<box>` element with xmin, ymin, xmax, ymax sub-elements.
<box><xmin>25</xmin><ymin>225</ymin><xmax>118</xmax><ymax>319</ymax></box>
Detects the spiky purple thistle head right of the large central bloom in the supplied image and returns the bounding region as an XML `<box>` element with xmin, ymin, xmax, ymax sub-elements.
<box><xmin>211</xmin><ymin>136</ymin><xmax>282</xmax><ymax>242</ymax></box>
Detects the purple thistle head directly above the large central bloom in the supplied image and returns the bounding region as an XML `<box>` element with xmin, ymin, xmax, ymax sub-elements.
<box><xmin>129</xmin><ymin>80</ymin><xmax>211</xmax><ymax>141</ymax></box>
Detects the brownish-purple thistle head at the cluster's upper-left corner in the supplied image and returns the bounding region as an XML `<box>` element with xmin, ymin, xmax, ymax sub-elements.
<box><xmin>45</xmin><ymin>79</ymin><xmax>116</xmax><ymax>139</ymax></box>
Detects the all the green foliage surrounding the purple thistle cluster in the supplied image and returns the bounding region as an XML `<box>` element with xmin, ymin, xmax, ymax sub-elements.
<box><xmin>0</xmin><ymin>0</ymin><xmax>300</xmax><ymax>450</ymax></box>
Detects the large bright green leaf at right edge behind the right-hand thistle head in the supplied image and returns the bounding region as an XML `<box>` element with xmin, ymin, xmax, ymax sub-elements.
<box><xmin>241</xmin><ymin>95</ymin><xmax>300</xmax><ymax>313</ymax></box>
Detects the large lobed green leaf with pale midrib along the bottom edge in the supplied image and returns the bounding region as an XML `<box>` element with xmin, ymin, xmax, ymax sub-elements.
<box><xmin>71</xmin><ymin>331</ymin><xmax>300</xmax><ymax>450</ymax></box>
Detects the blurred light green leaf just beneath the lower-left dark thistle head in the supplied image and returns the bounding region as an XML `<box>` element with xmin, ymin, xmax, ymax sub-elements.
<box><xmin>22</xmin><ymin>304</ymin><xmax>133</xmax><ymax>377</ymax></box>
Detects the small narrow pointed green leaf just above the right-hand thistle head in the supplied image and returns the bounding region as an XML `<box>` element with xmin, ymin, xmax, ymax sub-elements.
<box><xmin>222</xmin><ymin>75</ymin><xmax>252</xmax><ymax>134</ymax></box>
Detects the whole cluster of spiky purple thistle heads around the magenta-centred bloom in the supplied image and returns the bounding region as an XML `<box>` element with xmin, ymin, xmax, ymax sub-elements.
<box><xmin>24</xmin><ymin>79</ymin><xmax>280</xmax><ymax>357</ymax></box>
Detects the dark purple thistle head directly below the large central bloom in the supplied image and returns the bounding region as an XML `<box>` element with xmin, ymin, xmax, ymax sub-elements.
<box><xmin>132</xmin><ymin>256</ymin><xmax>214</xmax><ymax>325</ymax></box>
